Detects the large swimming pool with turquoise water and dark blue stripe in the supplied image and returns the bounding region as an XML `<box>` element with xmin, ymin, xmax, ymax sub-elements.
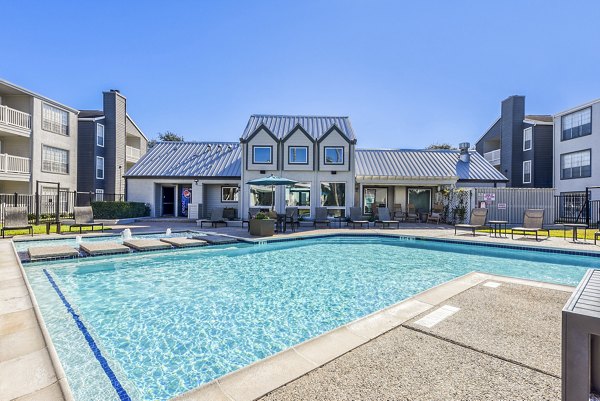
<box><xmin>25</xmin><ymin>236</ymin><xmax>600</xmax><ymax>400</ymax></box>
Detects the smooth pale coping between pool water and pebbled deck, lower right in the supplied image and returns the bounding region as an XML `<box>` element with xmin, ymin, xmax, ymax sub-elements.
<box><xmin>169</xmin><ymin>271</ymin><xmax>575</xmax><ymax>401</ymax></box>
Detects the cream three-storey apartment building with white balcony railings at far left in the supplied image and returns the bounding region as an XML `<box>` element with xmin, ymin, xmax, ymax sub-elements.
<box><xmin>0</xmin><ymin>80</ymin><xmax>79</xmax><ymax>194</ymax></box>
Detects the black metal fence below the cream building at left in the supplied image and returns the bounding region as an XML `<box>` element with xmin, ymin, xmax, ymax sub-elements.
<box><xmin>0</xmin><ymin>191</ymin><xmax>125</xmax><ymax>224</ymax></box>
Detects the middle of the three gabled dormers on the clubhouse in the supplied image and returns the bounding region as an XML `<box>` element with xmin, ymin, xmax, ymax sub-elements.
<box><xmin>281</xmin><ymin>124</ymin><xmax>315</xmax><ymax>171</ymax></box>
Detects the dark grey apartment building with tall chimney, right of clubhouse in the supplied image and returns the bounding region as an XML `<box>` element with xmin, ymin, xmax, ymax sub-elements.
<box><xmin>475</xmin><ymin>96</ymin><xmax>553</xmax><ymax>188</ymax></box>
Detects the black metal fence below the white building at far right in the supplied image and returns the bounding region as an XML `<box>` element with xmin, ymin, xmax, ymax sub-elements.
<box><xmin>554</xmin><ymin>191</ymin><xmax>600</xmax><ymax>228</ymax></box>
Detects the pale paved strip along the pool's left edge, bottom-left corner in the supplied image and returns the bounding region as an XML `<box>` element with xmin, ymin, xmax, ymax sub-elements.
<box><xmin>0</xmin><ymin>241</ymin><xmax>66</xmax><ymax>401</ymax></box>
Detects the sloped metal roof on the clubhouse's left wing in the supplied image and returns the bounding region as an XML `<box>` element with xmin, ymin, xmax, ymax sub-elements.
<box><xmin>125</xmin><ymin>142</ymin><xmax>242</xmax><ymax>178</ymax></box>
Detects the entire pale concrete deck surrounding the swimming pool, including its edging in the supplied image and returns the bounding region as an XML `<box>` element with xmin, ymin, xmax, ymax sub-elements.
<box><xmin>0</xmin><ymin>224</ymin><xmax>600</xmax><ymax>401</ymax></box>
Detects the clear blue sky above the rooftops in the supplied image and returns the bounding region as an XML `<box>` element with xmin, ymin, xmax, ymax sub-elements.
<box><xmin>0</xmin><ymin>0</ymin><xmax>600</xmax><ymax>148</ymax></box>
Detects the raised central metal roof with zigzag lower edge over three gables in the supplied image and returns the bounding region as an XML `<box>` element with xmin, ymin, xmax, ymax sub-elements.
<box><xmin>241</xmin><ymin>114</ymin><xmax>356</xmax><ymax>141</ymax></box>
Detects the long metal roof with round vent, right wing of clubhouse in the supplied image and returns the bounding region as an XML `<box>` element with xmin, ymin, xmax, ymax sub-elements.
<box><xmin>356</xmin><ymin>149</ymin><xmax>508</xmax><ymax>181</ymax></box>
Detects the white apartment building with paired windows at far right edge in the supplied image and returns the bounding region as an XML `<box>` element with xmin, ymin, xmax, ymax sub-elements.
<box><xmin>554</xmin><ymin>99</ymin><xmax>600</xmax><ymax>195</ymax></box>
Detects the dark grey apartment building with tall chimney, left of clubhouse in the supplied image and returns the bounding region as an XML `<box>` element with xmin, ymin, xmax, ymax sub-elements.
<box><xmin>77</xmin><ymin>90</ymin><xmax>148</xmax><ymax>200</ymax></box>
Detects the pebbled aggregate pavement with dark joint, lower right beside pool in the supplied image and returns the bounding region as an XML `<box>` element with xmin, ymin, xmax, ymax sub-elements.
<box><xmin>261</xmin><ymin>278</ymin><xmax>570</xmax><ymax>401</ymax></box>
